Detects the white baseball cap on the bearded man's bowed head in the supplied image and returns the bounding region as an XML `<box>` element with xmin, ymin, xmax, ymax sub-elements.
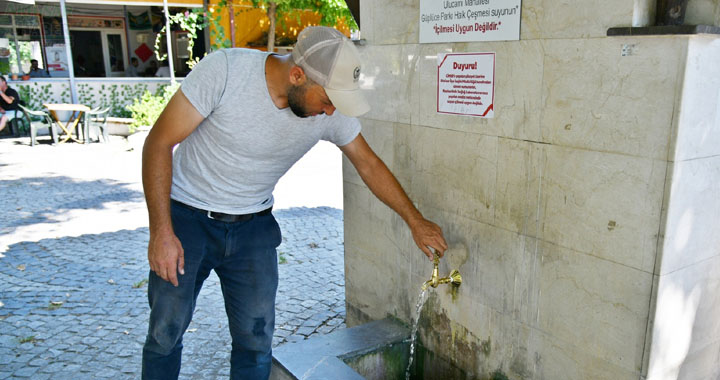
<box><xmin>292</xmin><ymin>26</ymin><xmax>370</xmax><ymax>117</ymax></box>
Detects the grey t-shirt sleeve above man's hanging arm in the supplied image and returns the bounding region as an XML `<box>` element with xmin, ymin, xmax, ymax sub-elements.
<box><xmin>180</xmin><ymin>50</ymin><xmax>228</xmax><ymax>117</ymax></box>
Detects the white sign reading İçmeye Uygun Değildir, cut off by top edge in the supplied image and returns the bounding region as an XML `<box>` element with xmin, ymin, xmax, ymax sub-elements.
<box><xmin>420</xmin><ymin>0</ymin><xmax>522</xmax><ymax>44</ymax></box>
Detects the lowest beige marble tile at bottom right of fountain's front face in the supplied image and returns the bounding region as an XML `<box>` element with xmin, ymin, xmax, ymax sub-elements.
<box><xmin>537</xmin><ymin>242</ymin><xmax>652</xmax><ymax>378</ymax></box>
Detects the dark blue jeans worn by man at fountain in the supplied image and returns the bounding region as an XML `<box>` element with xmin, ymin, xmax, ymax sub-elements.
<box><xmin>142</xmin><ymin>202</ymin><xmax>281</xmax><ymax>380</ymax></box>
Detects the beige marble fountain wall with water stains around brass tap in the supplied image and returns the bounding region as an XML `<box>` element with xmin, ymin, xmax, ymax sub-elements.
<box><xmin>344</xmin><ymin>0</ymin><xmax>720</xmax><ymax>380</ymax></box>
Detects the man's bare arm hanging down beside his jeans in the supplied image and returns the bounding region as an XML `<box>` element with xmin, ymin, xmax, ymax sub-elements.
<box><xmin>142</xmin><ymin>90</ymin><xmax>203</xmax><ymax>286</ymax></box>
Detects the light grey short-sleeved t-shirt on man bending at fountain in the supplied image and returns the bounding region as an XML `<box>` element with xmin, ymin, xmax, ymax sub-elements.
<box><xmin>170</xmin><ymin>49</ymin><xmax>360</xmax><ymax>214</ymax></box>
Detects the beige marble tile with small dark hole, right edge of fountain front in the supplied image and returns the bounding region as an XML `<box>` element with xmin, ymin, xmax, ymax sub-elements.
<box><xmin>540</xmin><ymin>145</ymin><xmax>667</xmax><ymax>273</ymax></box>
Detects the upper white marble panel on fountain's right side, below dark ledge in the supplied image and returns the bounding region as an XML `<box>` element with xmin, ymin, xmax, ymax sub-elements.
<box><xmin>674</xmin><ymin>36</ymin><xmax>720</xmax><ymax>161</ymax></box>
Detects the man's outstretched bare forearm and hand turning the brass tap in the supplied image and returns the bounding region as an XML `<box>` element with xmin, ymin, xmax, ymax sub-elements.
<box><xmin>340</xmin><ymin>134</ymin><xmax>447</xmax><ymax>260</ymax></box>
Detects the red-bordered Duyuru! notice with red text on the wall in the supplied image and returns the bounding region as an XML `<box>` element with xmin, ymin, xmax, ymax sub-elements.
<box><xmin>437</xmin><ymin>53</ymin><xmax>495</xmax><ymax>118</ymax></box>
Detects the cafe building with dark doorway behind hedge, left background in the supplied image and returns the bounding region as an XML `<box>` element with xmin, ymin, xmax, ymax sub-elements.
<box><xmin>0</xmin><ymin>0</ymin><xmax>207</xmax><ymax>80</ymax></box>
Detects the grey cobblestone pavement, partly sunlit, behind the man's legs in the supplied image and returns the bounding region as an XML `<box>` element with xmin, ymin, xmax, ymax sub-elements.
<box><xmin>0</xmin><ymin>139</ymin><xmax>345</xmax><ymax>379</ymax></box>
